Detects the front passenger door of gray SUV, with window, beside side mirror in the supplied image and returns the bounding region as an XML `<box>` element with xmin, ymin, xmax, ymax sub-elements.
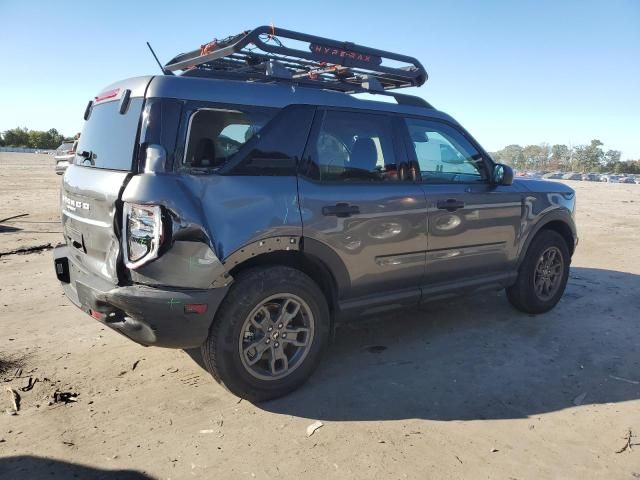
<box><xmin>404</xmin><ymin>118</ymin><xmax>522</xmax><ymax>288</ymax></box>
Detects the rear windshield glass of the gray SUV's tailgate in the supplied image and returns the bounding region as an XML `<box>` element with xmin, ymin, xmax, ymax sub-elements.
<box><xmin>75</xmin><ymin>98</ymin><xmax>142</xmax><ymax>170</ymax></box>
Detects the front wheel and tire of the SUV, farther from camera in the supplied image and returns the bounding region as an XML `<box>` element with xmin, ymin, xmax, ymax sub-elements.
<box><xmin>507</xmin><ymin>230</ymin><xmax>571</xmax><ymax>314</ymax></box>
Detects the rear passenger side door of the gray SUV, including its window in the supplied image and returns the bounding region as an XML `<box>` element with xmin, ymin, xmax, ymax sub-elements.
<box><xmin>299</xmin><ymin>109</ymin><xmax>426</xmax><ymax>303</ymax></box>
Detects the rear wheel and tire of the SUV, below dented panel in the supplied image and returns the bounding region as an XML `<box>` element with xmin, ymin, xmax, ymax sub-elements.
<box><xmin>202</xmin><ymin>266</ymin><xmax>330</xmax><ymax>401</ymax></box>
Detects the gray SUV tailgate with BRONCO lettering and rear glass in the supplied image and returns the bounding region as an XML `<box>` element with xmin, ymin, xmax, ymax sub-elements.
<box><xmin>61</xmin><ymin>79</ymin><xmax>148</xmax><ymax>283</ymax></box>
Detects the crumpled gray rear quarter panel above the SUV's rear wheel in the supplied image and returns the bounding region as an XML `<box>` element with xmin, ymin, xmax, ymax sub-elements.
<box><xmin>123</xmin><ymin>173</ymin><xmax>302</xmax><ymax>288</ymax></box>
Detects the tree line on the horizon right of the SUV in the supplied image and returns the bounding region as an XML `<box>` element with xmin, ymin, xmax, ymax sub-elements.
<box><xmin>491</xmin><ymin>139</ymin><xmax>640</xmax><ymax>174</ymax></box>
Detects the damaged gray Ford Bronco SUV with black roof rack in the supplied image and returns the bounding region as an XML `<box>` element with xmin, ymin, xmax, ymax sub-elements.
<box><xmin>54</xmin><ymin>27</ymin><xmax>577</xmax><ymax>401</ymax></box>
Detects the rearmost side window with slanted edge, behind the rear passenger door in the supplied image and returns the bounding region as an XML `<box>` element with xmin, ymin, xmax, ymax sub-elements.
<box><xmin>183</xmin><ymin>107</ymin><xmax>275</xmax><ymax>169</ymax></box>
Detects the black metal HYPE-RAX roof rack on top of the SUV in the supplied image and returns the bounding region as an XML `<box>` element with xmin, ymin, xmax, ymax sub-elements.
<box><xmin>164</xmin><ymin>26</ymin><xmax>429</xmax><ymax>97</ymax></box>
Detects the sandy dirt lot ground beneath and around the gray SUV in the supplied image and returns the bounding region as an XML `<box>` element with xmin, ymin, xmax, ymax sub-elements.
<box><xmin>0</xmin><ymin>154</ymin><xmax>640</xmax><ymax>479</ymax></box>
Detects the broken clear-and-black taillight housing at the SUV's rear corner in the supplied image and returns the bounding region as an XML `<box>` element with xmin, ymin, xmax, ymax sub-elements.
<box><xmin>122</xmin><ymin>203</ymin><xmax>163</xmax><ymax>268</ymax></box>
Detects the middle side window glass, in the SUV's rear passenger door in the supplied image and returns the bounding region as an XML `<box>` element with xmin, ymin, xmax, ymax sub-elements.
<box><xmin>307</xmin><ymin>110</ymin><xmax>399</xmax><ymax>182</ymax></box>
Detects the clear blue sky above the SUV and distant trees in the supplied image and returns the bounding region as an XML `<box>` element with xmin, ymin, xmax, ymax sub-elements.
<box><xmin>0</xmin><ymin>0</ymin><xmax>640</xmax><ymax>159</ymax></box>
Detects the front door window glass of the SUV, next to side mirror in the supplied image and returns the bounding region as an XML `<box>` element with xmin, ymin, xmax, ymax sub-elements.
<box><xmin>405</xmin><ymin>118</ymin><xmax>487</xmax><ymax>183</ymax></box>
